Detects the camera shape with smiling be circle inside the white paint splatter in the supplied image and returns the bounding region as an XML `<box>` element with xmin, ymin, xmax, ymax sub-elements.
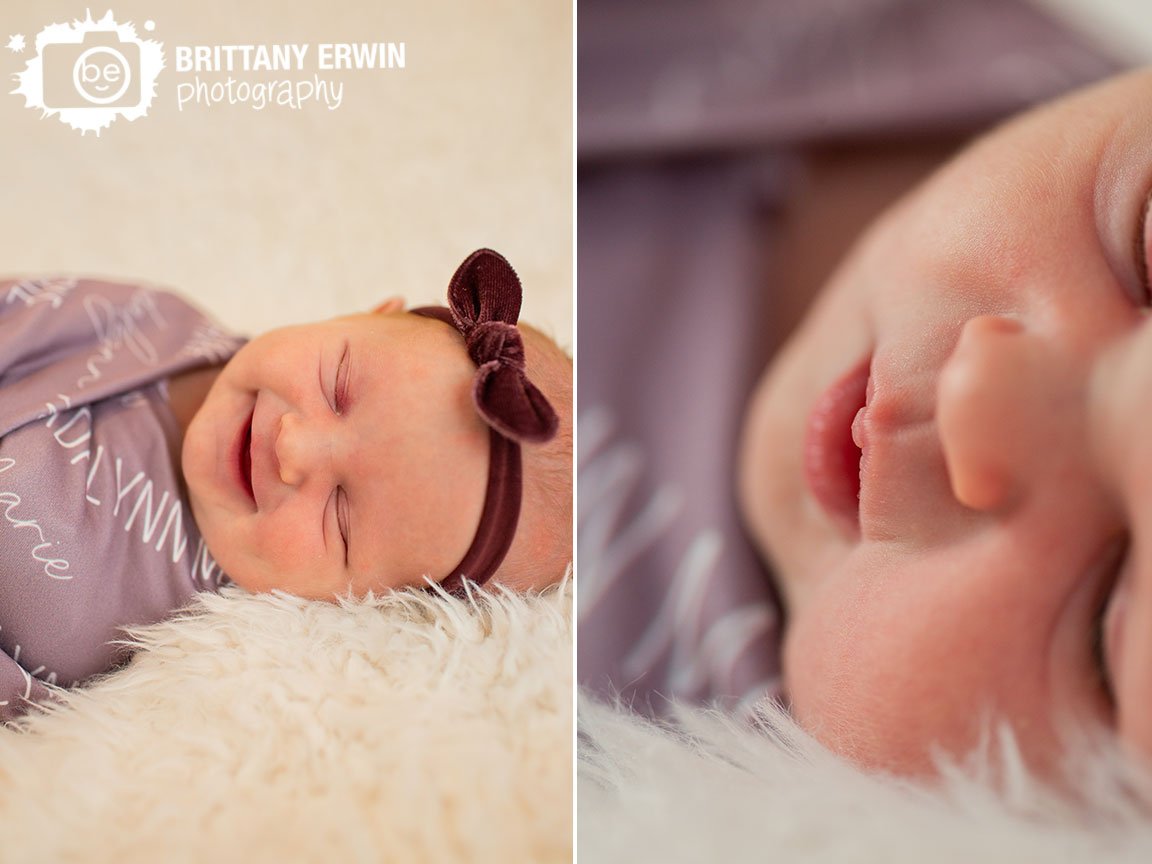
<box><xmin>40</xmin><ymin>32</ymin><xmax>141</xmax><ymax>108</ymax></box>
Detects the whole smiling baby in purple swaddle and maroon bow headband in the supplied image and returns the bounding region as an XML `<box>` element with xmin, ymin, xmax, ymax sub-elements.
<box><xmin>0</xmin><ymin>250</ymin><xmax>571</xmax><ymax>718</ymax></box>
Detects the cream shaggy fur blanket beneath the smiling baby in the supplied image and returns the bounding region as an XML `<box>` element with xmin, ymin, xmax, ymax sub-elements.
<box><xmin>0</xmin><ymin>582</ymin><xmax>573</xmax><ymax>863</ymax></box>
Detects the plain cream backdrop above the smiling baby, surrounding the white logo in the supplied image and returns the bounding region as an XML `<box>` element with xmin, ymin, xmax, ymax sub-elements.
<box><xmin>0</xmin><ymin>0</ymin><xmax>573</xmax><ymax>348</ymax></box>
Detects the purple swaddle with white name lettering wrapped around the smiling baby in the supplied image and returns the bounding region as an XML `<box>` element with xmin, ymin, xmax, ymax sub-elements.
<box><xmin>0</xmin><ymin>279</ymin><xmax>242</xmax><ymax>719</ymax></box>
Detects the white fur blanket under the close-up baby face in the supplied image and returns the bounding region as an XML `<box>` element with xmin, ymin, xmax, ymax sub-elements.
<box><xmin>577</xmin><ymin>700</ymin><xmax>1152</xmax><ymax>864</ymax></box>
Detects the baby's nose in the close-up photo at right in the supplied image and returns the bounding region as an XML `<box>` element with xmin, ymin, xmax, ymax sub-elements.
<box><xmin>937</xmin><ymin>314</ymin><xmax>1061</xmax><ymax>510</ymax></box>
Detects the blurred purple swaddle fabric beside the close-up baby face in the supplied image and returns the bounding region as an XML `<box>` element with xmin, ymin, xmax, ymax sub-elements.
<box><xmin>577</xmin><ymin>0</ymin><xmax>1120</xmax><ymax>712</ymax></box>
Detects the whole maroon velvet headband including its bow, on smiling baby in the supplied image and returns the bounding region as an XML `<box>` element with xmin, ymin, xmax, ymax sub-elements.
<box><xmin>411</xmin><ymin>249</ymin><xmax>559</xmax><ymax>591</ymax></box>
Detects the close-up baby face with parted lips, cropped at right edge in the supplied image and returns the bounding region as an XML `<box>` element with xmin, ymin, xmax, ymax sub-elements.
<box><xmin>740</xmin><ymin>71</ymin><xmax>1152</xmax><ymax>773</ymax></box>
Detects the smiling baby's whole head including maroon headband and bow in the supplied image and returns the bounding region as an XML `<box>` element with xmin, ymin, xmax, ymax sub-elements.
<box><xmin>182</xmin><ymin>250</ymin><xmax>573</xmax><ymax>599</ymax></box>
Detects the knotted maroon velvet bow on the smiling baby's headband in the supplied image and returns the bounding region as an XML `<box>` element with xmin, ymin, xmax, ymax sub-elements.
<box><xmin>448</xmin><ymin>249</ymin><xmax>558</xmax><ymax>442</ymax></box>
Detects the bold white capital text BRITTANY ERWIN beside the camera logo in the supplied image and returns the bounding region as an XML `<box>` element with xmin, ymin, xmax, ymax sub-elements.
<box><xmin>176</xmin><ymin>41</ymin><xmax>406</xmax><ymax>73</ymax></box>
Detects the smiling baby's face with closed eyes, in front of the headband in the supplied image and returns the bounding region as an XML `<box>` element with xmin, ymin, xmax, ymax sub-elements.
<box><xmin>182</xmin><ymin>312</ymin><xmax>488</xmax><ymax>599</ymax></box>
